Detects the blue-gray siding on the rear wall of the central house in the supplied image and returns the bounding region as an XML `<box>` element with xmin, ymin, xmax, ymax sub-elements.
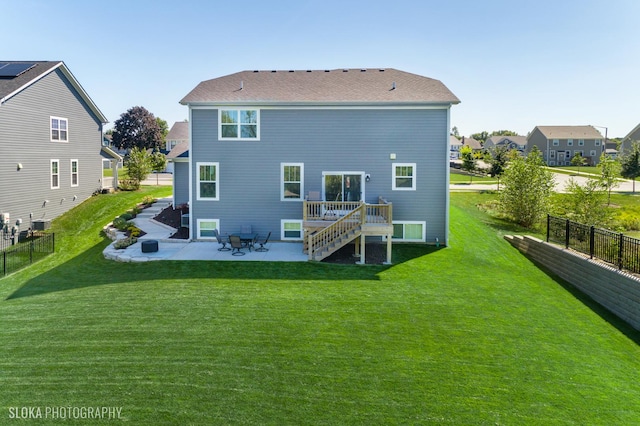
<box><xmin>190</xmin><ymin>108</ymin><xmax>449</xmax><ymax>242</ymax></box>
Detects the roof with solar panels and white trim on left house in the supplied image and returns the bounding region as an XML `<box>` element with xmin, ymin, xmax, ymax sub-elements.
<box><xmin>0</xmin><ymin>61</ymin><xmax>109</xmax><ymax>124</ymax></box>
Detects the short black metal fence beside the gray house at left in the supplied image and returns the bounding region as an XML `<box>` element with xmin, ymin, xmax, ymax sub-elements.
<box><xmin>0</xmin><ymin>232</ymin><xmax>55</xmax><ymax>276</ymax></box>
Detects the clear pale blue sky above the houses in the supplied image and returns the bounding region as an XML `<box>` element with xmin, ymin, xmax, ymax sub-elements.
<box><xmin>0</xmin><ymin>0</ymin><xmax>640</xmax><ymax>137</ymax></box>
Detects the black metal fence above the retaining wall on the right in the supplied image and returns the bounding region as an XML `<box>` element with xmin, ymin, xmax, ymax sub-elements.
<box><xmin>547</xmin><ymin>216</ymin><xmax>640</xmax><ymax>274</ymax></box>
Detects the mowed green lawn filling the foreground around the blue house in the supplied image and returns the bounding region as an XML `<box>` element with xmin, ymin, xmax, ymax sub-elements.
<box><xmin>0</xmin><ymin>187</ymin><xmax>640</xmax><ymax>425</ymax></box>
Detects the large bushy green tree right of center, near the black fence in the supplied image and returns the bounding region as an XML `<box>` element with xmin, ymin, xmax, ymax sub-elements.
<box><xmin>499</xmin><ymin>148</ymin><xmax>555</xmax><ymax>227</ymax></box>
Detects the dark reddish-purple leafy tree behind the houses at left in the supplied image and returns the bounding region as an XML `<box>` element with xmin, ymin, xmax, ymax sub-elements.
<box><xmin>112</xmin><ymin>106</ymin><xmax>164</xmax><ymax>149</ymax></box>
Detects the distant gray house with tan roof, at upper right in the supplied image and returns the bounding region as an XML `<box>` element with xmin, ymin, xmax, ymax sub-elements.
<box><xmin>526</xmin><ymin>126</ymin><xmax>605</xmax><ymax>166</ymax></box>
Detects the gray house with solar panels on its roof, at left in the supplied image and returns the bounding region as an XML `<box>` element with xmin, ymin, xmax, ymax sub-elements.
<box><xmin>0</xmin><ymin>61</ymin><xmax>107</xmax><ymax>235</ymax></box>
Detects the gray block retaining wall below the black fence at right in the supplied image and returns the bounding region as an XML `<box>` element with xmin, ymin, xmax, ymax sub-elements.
<box><xmin>504</xmin><ymin>235</ymin><xmax>640</xmax><ymax>330</ymax></box>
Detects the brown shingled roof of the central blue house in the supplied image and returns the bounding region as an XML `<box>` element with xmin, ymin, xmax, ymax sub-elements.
<box><xmin>180</xmin><ymin>68</ymin><xmax>460</xmax><ymax>105</ymax></box>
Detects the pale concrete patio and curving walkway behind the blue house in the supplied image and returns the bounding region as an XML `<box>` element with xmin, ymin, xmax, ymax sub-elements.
<box><xmin>102</xmin><ymin>198</ymin><xmax>308</xmax><ymax>262</ymax></box>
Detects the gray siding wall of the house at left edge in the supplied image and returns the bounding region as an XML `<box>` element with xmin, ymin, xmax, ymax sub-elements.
<box><xmin>0</xmin><ymin>70</ymin><xmax>102</xmax><ymax>230</ymax></box>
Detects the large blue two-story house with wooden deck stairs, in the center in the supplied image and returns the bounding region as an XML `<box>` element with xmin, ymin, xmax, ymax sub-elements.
<box><xmin>179</xmin><ymin>68</ymin><xmax>460</xmax><ymax>259</ymax></box>
